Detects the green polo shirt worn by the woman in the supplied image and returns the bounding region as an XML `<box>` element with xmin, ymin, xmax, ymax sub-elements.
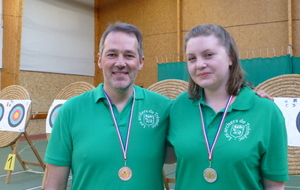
<box><xmin>168</xmin><ymin>87</ymin><xmax>288</xmax><ymax>190</ymax></box>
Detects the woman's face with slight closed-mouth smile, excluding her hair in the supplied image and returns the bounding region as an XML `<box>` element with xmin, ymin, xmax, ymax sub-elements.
<box><xmin>186</xmin><ymin>35</ymin><xmax>232</xmax><ymax>91</ymax></box>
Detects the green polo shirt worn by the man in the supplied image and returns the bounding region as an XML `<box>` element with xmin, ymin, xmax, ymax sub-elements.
<box><xmin>45</xmin><ymin>84</ymin><xmax>172</xmax><ymax>190</ymax></box>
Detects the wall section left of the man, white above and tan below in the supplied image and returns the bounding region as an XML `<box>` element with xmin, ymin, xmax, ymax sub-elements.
<box><xmin>19</xmin><ymin>0</ymin><xmax>94</xmax><ymax>135</ymax></box>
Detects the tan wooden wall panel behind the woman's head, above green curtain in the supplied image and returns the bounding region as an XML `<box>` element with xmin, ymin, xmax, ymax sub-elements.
<box><xmin>183</xmin><ymin>0</ymin><xmax>300</xmax><ymax>59</ymax></box>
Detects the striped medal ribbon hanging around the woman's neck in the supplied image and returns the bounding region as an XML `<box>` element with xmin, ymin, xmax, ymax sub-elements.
<box><xmin>198</xmin><ymin>95</ymin><xmax>233</xmax><ymax>161</ymax></box>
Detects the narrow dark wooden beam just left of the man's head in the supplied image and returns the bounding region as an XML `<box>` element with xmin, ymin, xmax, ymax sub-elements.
<box><xmin>94</xmin><ymin>0</ymin><xmax>103</xmax><ymax>86</ymax></box>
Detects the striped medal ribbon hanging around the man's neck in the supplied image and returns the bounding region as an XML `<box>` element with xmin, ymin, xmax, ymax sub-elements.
<box><xmin>103</xmin><ymin>89</ymin><xmax>135</xmax><ymax>160</ymax></box>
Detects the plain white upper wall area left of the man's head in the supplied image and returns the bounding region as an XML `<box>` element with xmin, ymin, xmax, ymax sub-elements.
<box><xmin>20</xmin><ymin>0</ymin><xmax>94</xmax><ymax>76</ymax></box>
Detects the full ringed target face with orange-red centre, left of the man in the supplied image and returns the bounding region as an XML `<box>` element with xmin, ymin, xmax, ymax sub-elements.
<box><xmin>8</xmin><ymin>104</ymin><xmax>25</xmax><ymax>127</ymax></box>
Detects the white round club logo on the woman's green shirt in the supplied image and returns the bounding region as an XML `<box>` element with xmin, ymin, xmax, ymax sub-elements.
<box><xmin>224</xmin><ymin>119</ymin><xmax>251</xmax><ymax>141</ymax></box>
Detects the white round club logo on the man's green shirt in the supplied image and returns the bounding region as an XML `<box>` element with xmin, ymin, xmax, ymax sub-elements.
<box><xmin>139</xmin><ymin>110</ymin><xmax>159</xmax><ymax>128</ymax></box>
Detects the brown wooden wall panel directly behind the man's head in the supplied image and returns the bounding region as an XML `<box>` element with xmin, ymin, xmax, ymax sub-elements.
<box><xmin>99</xmin><ymin>0</ymin><xmax>177</xmax><ymax>87</ymax></box>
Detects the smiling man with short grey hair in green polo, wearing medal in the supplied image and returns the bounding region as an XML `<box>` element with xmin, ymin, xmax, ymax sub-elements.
<box><xmin>45</xmin><ymin>23</ymin><xmax>172</xmax><ymax>190</ymax></box>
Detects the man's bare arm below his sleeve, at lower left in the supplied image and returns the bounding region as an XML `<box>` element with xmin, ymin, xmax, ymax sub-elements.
<box><xmin>45</xmin><ymin>164</ymin><xmax>70</xmax><ymax>190</ymax></box>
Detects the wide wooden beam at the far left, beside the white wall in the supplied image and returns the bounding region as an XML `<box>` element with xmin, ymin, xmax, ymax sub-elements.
<box><xmin>1</xmin><ymin>0</ymin><xmax>23</xmax><ymax>89</ymax></box>
